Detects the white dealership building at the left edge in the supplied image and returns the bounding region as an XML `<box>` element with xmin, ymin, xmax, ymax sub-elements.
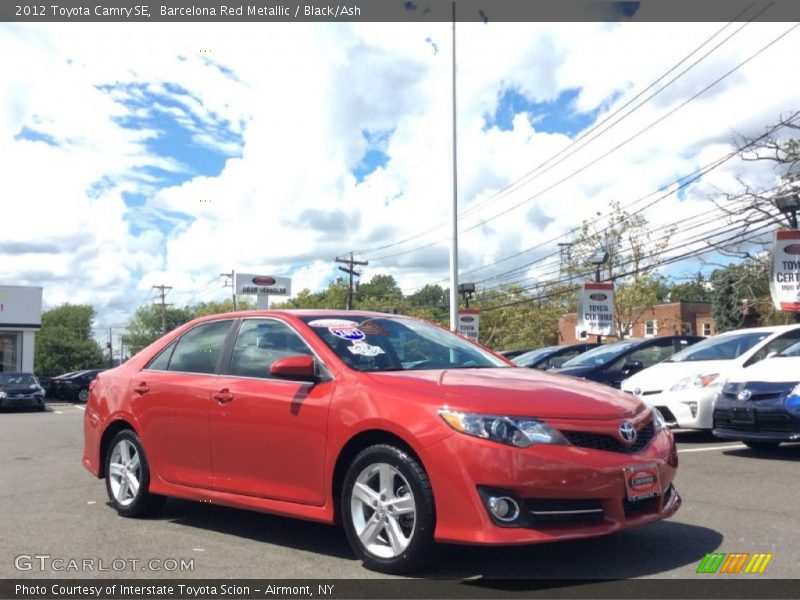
<box><xmin>0</xmin><ymin>285</ymin><xmax>42</xmax><ymax>372</ymax></box>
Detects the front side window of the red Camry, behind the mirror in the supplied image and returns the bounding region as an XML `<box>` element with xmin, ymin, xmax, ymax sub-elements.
<box><xmin>228</xmin><ymin>319</ymin><xmax>313</xmax><ymax>379</ymax></box>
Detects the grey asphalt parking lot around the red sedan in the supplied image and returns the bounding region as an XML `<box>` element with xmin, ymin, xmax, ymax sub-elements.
<box><xmin>0</xmin><ymin>402</ymin><xmax>800</xmax><ymax>579</ymax></box>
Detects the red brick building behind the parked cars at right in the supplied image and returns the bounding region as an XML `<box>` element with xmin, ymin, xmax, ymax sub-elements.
<box><xmin>558</xmin><ymin>302</ymin><xmax>717</xmax><ymax>344</ymax></box>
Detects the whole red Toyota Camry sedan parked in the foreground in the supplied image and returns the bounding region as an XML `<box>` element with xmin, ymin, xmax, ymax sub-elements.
<box><xmin>83</xmin><ymin>311</ymin><xmax>681</xmax><ymax>573</ymax></box>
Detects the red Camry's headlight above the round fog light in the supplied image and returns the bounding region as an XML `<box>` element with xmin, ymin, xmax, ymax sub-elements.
<box><xmin>439</xmin><ymin>408</ymin><xmax>569</xmax><ymax>448</ymax></box>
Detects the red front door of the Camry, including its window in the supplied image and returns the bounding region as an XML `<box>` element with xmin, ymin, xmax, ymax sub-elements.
<box><xmin>211</xmin><ymin>318</ymin><xmax>334</xmax><ymax>506</ymax></box>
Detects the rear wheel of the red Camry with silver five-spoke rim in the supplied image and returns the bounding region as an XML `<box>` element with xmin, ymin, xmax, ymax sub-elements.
<box><xmin>105</xmin><ymin>429</ymin><xmax>165</xmax><ymax>517</ymax></box>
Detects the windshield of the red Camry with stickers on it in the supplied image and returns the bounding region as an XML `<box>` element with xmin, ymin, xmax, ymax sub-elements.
<box><xmin>303</xmin><ymin>315</ymin><xmax>510</xmax><ymax>371</ymax></box>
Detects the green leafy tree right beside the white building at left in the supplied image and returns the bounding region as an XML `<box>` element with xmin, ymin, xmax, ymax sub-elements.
<box><xmin>34</xmin><ymin>304</ymin><xmax>103</xmax><ymax>377</ymax></box>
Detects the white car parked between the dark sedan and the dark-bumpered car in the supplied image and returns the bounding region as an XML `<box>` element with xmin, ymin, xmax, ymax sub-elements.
<box><xmin>621</xmin><ymin>324</ymin><xmax>800</xmax><ymax>429</ymax></box>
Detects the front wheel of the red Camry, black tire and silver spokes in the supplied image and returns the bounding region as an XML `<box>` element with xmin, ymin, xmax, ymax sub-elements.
<box><xmin>341</xmin><ymin>444</ymin><xmax>436</xmax><ymax>575</ymax></box>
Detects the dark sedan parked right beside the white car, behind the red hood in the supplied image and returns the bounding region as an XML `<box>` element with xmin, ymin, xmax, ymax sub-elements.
<box><xmin>555</xmin><ymin>335</ymin><xmax>705</xmax><ymax>388</ymax></box>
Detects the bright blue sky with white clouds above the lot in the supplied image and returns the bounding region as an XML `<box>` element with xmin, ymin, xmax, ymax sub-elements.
<box><xmin>0</xmin><ymin>12</ymin><xmax>800</xmax><ymax>346</ymax></box>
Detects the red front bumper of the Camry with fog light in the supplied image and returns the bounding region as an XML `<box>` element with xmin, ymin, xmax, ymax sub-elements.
<box><xmin>428</xmin><ymin>424</ymin><xmax>681</xmax><ymax>545</ymax></box>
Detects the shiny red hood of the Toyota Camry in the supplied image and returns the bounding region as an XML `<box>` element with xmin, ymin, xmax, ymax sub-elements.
<box><xmin>365</xmin><ymin>367</ymin><xmax>641</xmax><ymax>419</ymax></box>
